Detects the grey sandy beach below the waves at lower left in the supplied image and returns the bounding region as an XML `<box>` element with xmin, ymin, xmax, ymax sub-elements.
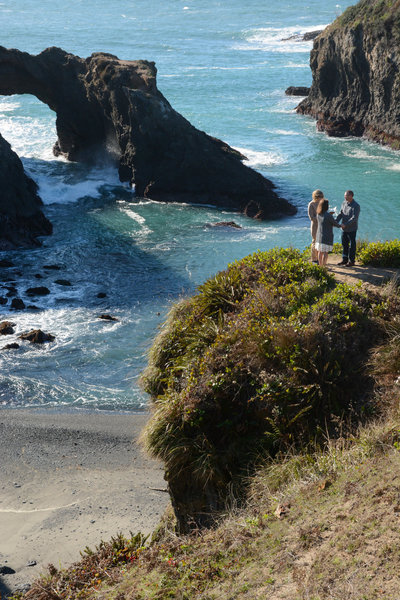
<box><xmin>0</xmin><ymin>408</ymin><xmax>169</xmax><ymax>598</ymax></box>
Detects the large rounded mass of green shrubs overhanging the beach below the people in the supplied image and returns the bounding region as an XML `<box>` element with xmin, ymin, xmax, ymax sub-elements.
<box><xmin>143</xmin><ymin>249</ymin><xmax>392</xmax><ymax>530</ymax></box>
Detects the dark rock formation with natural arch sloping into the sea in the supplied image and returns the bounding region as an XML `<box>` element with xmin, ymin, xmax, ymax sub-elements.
<box><xmin>0</xmin><ymin>47</ymin><xmax>296</xmax><ymax>218</ymax></box>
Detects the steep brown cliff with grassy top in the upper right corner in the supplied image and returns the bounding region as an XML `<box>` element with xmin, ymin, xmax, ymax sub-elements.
<box><xmin>297</xmin><ymin>0</ymin><xmax>400</xmax><ymax>149</ymax></box>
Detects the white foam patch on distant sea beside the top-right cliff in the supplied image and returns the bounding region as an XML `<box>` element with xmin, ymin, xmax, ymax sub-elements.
<box><xmin>235</xmin><ymin>25</ymin><xmax>326</xmax><ymax>53</ymax></box>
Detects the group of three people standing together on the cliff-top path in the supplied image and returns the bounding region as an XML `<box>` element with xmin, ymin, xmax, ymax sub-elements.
<box><xmin>308</xmin><ymin>190</ymin><xmax>360</xmax><ymax>267</ymax></box>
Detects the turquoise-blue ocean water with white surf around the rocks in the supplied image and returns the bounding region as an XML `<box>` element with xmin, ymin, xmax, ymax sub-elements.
<box><xmin>0</xmin><ymin>0</ymin><xmax>400</xmax><ymax>411</ymax></box>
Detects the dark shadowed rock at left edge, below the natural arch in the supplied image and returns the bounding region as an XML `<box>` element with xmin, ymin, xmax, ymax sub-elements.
<box><xmin>0</xmin><ymin>135</ymin><xmax>52</xmax><ymax>250</ymax></box>
